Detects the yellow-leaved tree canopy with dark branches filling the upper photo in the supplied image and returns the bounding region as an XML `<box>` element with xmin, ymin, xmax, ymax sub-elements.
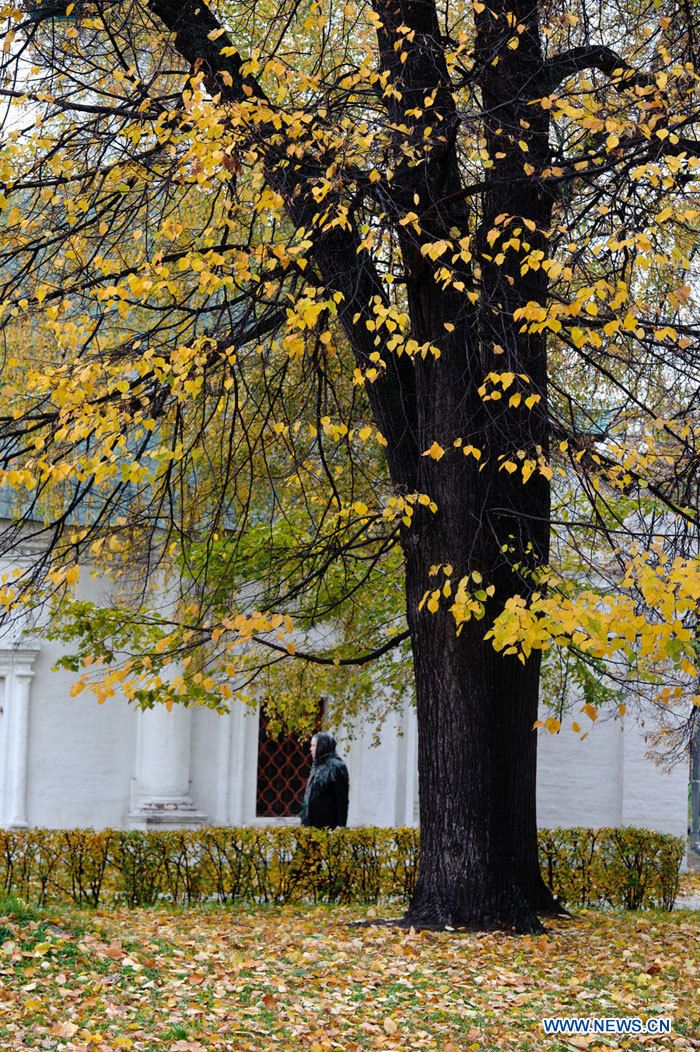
<box><xmin>0</xmin><ymin>0</ymin><xmax>700</xmax><ymax>924</ymax></box>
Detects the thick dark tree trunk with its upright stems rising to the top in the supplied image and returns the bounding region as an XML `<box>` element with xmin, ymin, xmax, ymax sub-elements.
<box><xmin>382</xmin><ymin>2</ymin><xmax>557</xmax><ymax>931</ymax></box>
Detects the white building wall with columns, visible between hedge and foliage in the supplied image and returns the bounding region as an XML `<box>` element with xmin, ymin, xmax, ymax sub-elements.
<box><xmin>0</xmin><ymin>614</ymin><xmax>688</xmax><ymax>836</ymax></box>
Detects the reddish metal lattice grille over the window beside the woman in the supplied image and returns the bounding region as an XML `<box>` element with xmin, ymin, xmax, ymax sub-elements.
<box><xmin>255</xmin><ymin>712</ymin><xmax>311</xmax><ymax>818</ymax></box>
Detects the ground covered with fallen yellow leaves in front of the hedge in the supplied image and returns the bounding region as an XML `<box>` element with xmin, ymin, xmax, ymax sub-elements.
<box><xmin>0</xmin><ymin>903</ymin><xmax>700</xmax><ymax>1052</ymax></box>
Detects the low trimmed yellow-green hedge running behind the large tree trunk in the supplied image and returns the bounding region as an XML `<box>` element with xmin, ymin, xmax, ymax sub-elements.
<box><xmin>0</xmin><ymin>826</ymin><xmax>685</xmax><ymax>910</ymax></box>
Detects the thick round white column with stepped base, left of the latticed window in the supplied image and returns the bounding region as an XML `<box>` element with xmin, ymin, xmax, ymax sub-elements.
<box><xmin>128</xmin><ymin>705</ymin><xmax>206</xmax><ymax>829</ymax></box>
